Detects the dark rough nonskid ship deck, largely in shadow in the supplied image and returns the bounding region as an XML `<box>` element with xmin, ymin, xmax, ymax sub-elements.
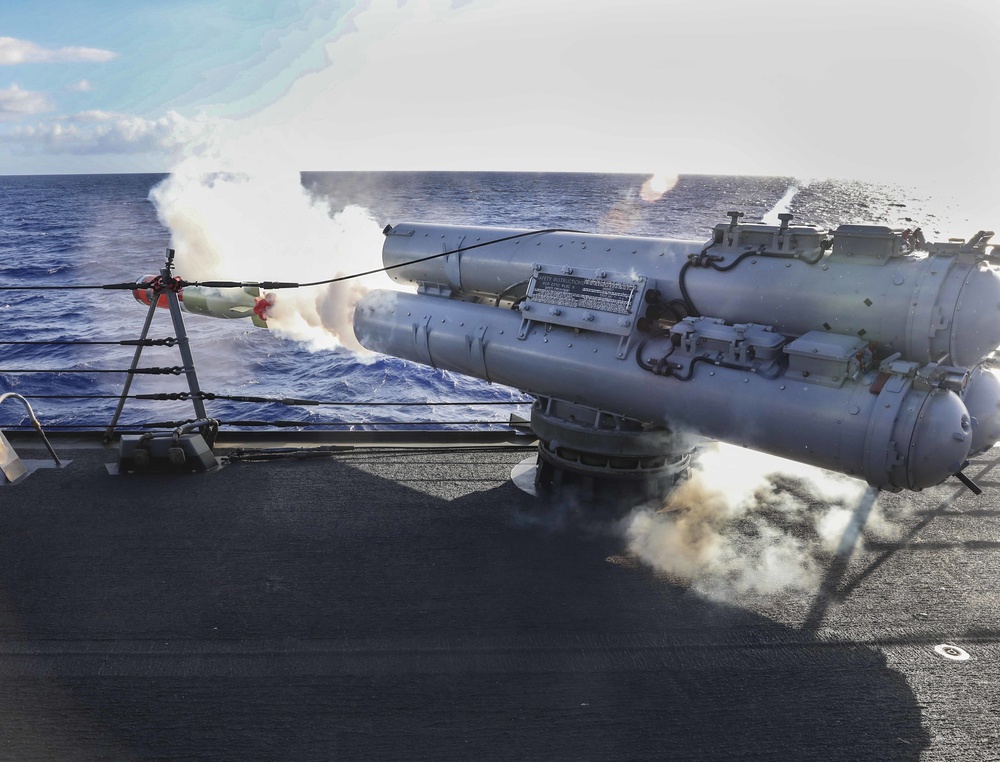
<box><xmin>0</xmin><ymin>444</ymin><xmax>1000</xmax><ymax>760</ymax></box>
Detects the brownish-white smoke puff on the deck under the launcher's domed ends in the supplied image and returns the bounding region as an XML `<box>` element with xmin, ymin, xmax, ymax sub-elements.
<box><xmin>621</xmin><ymin>444</ymin><xmax>893</xmax><ymax>600</ymax></box>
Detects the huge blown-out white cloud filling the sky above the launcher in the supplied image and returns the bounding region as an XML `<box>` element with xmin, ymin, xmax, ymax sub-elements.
<box><xmin>221</xmin><ymin>0</ymin><xmax>1000</xmax><ymax>180</ymax></box>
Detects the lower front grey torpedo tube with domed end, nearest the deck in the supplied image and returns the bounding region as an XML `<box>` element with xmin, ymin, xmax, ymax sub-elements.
<box><xmin>354</xmin><ymin>288</ymin><xmax>972</xmax><ymax>491</ymax></box>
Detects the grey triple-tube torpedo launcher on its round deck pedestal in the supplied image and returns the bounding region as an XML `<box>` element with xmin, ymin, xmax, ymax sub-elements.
<box><xmin>354</xmin><ymin>212</ymin><xmax>1000</xmax><ymax>492</ymax></box>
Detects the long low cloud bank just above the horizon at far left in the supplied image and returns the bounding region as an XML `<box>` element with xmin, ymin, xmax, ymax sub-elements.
<box><xmin>5</xmin><ymin>111</ymin><xmax>214</xmax><ymax>155</ymax></box>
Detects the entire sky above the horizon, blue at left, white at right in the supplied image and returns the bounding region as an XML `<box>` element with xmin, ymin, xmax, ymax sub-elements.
<box><xmin>0</xmin><ymin>0</ymin><xmax>1000</xmax><ymax>204</ymax></box>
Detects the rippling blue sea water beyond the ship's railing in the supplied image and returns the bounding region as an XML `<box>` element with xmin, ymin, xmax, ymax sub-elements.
<box><xmin>0</xmin><ymin>172</ymin><xmax>956</xmax><ymax>429</ymax></box>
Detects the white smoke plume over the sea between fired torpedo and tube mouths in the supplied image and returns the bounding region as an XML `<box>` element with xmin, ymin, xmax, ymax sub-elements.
<box><xmin>150</xmin><ymin>130</ymin><xmax>391</xmax><ymax>350</ymax></box>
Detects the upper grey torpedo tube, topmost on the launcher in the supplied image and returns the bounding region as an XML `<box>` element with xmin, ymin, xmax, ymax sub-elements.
<box><xmin>382</xmin><ymin>220</ymin><xmax>1000</xmax><ymax>367</ymax></box>
